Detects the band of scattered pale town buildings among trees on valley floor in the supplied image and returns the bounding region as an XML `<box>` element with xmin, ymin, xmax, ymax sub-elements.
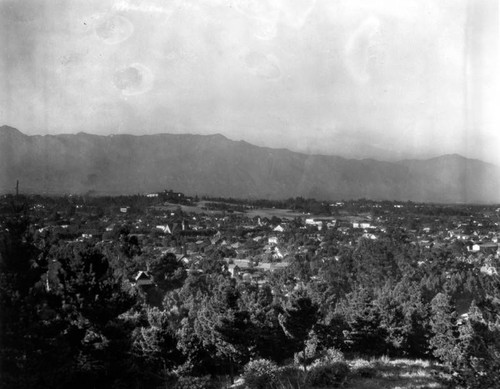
<box><xmin>0</xmin><ymin>191</ymin><xmax>500</xmax><ymax>285</ymax></box>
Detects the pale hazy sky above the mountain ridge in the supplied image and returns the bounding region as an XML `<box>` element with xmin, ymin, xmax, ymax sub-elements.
<box><xmin>0</xmin><ymin>0</ymin><xmax>500</xmax><ymax>165</ymax></box>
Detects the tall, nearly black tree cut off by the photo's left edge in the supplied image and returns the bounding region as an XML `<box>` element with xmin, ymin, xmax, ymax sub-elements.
<box><xmin>0</xmin><ymin>198</ymin><xmax>50</xmax><ymax>388</ymax></box>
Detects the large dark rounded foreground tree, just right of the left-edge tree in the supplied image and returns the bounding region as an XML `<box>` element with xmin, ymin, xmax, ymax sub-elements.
<box><xmin>40</xmin><ymin>243</ymin><xmax>136</xmax><ymax>388</ymax></box>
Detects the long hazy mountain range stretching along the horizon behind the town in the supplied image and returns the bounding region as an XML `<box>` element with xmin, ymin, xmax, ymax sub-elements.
<box><xmin>0</xmin><ymin>126</ymin><xmax>500</xmax><ymax>203</ymax></box>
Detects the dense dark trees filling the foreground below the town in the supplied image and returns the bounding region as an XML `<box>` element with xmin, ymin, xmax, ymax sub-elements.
<box><xmin>0</xmin><ymin>197</ymin><xmax>500</xmax><ymax>389</ymax></box>
